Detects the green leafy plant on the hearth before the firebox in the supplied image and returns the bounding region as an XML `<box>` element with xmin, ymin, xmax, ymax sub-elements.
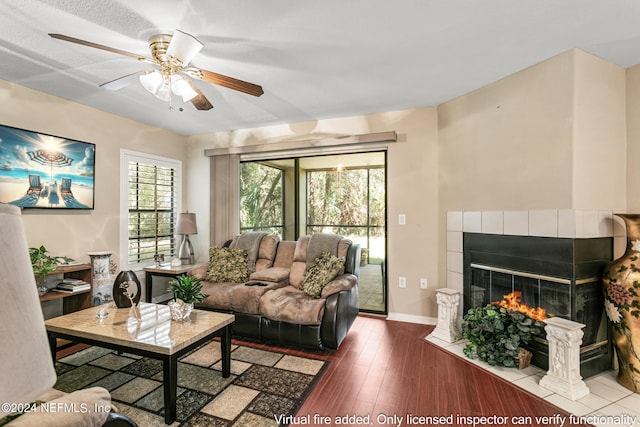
<box><xmin>462</xmin><ymin>304</ymin><xmax>542</xmax><ymax>367</ymax></box>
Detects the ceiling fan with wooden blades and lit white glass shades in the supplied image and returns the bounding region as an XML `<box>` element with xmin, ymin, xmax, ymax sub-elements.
<box><xmin>49</xmin><ymin>30</ymin><xmax>264</xmax><ymax>110</ymax></box>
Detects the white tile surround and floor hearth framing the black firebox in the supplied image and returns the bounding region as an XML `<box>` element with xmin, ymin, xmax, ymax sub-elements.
<box><xmin>444</xmin><ymin>210</ymin><xmax>640</xmax><ymax>426</ymax></box>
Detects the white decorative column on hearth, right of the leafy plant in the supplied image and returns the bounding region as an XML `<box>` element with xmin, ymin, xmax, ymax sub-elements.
<box><xmin>540</xmin><ymin>317</ymin><xmax>589</xmax><ymax>400</ymax></box>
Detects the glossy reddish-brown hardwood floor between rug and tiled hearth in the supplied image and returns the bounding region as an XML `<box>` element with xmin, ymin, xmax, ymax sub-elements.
<box><xmin>290</xmin><ymin>315</ymin><xmax>592</xmax><ymax>426</ymax></box>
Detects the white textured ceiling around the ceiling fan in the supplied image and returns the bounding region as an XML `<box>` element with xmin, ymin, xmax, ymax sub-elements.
<box><xmin>0</xmin><ymin>0</ymin><xmax>640</xmax><ymax>135</ymax></box>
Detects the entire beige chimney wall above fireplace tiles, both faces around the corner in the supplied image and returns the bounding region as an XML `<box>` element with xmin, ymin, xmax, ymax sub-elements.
<box><xmin>438</xmin><ymin>50</ymin><xmax>626</xmax><ymax>212</ymax></box>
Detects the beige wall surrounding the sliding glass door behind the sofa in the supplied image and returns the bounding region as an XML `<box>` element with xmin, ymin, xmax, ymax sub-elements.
<box><xmin>187</xmin><ymin>108</ymin><xmax>442</xmax><ymax>321</ymax></box>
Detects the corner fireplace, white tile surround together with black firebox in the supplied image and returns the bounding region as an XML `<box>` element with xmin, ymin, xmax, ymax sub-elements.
<box><xmin>447</xmin><ymin>210</ymin><xmax>626</xmax><ymax>377</ymax></box>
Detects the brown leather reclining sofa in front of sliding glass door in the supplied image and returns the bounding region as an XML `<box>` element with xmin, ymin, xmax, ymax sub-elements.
<box><xmin>189</xmin><ymin>233</ymin><xmax>360</xmax><ymax>349</ymax></box>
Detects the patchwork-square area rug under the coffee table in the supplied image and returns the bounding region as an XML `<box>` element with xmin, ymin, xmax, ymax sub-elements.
<box><xmin>54</xmin><ymin>341</ymin><xmax>329</xmax><ymax>427</ymax></box>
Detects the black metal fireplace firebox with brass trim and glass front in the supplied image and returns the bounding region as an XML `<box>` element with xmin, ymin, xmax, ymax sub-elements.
<box><xmin>463</xmin><ymin>233</ymin><xmax>613</xmax><ymax>378</ymax></box>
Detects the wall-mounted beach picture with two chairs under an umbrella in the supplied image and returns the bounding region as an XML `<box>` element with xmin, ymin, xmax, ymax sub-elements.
<box><xmin>0</xmin><ymin>125</ymin><xmax>95</xmax><ymax>209</ymax></box>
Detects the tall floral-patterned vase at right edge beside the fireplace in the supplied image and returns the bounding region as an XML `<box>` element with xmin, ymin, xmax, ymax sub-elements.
<box><xmin>602</xmin><ymin>214</ymin><xmax>640</xmax><ymax>393</ymax></box>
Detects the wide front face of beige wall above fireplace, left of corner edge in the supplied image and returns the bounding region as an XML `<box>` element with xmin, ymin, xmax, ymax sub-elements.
<box><xmin>438</xmin><ymin>52</ymin><xmax>573</xmax><ymax>212</ymax></box>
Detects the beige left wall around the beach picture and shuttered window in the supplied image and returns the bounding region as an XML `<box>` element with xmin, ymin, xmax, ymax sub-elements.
<box><xmin>0</xmin><ymin>81</ymin><xmax>186</xmax><ymax>264</ymax></box>
